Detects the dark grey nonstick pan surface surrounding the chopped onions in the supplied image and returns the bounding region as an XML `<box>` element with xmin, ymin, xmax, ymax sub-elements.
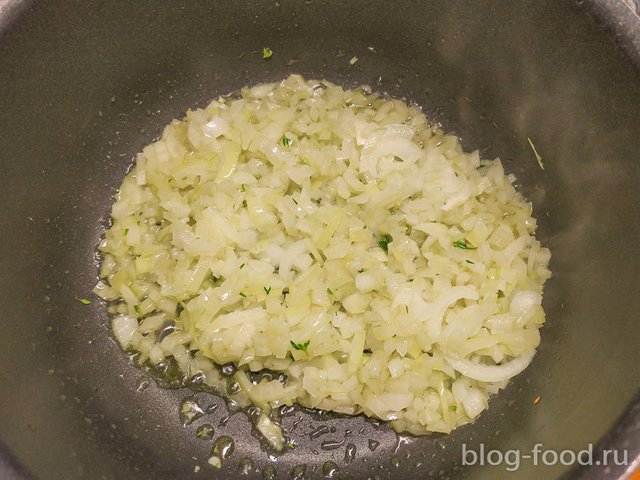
<box><xmin>0</xmin><ymin>0</ymin><xmax>640</xmax><ymax>480</ymax></box>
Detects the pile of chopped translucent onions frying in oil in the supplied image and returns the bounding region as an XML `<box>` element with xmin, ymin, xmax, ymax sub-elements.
<box><xmin>96</xmin><ymin>75</ymin><xmax>550</xmax><ymax>449</ymax></box>
